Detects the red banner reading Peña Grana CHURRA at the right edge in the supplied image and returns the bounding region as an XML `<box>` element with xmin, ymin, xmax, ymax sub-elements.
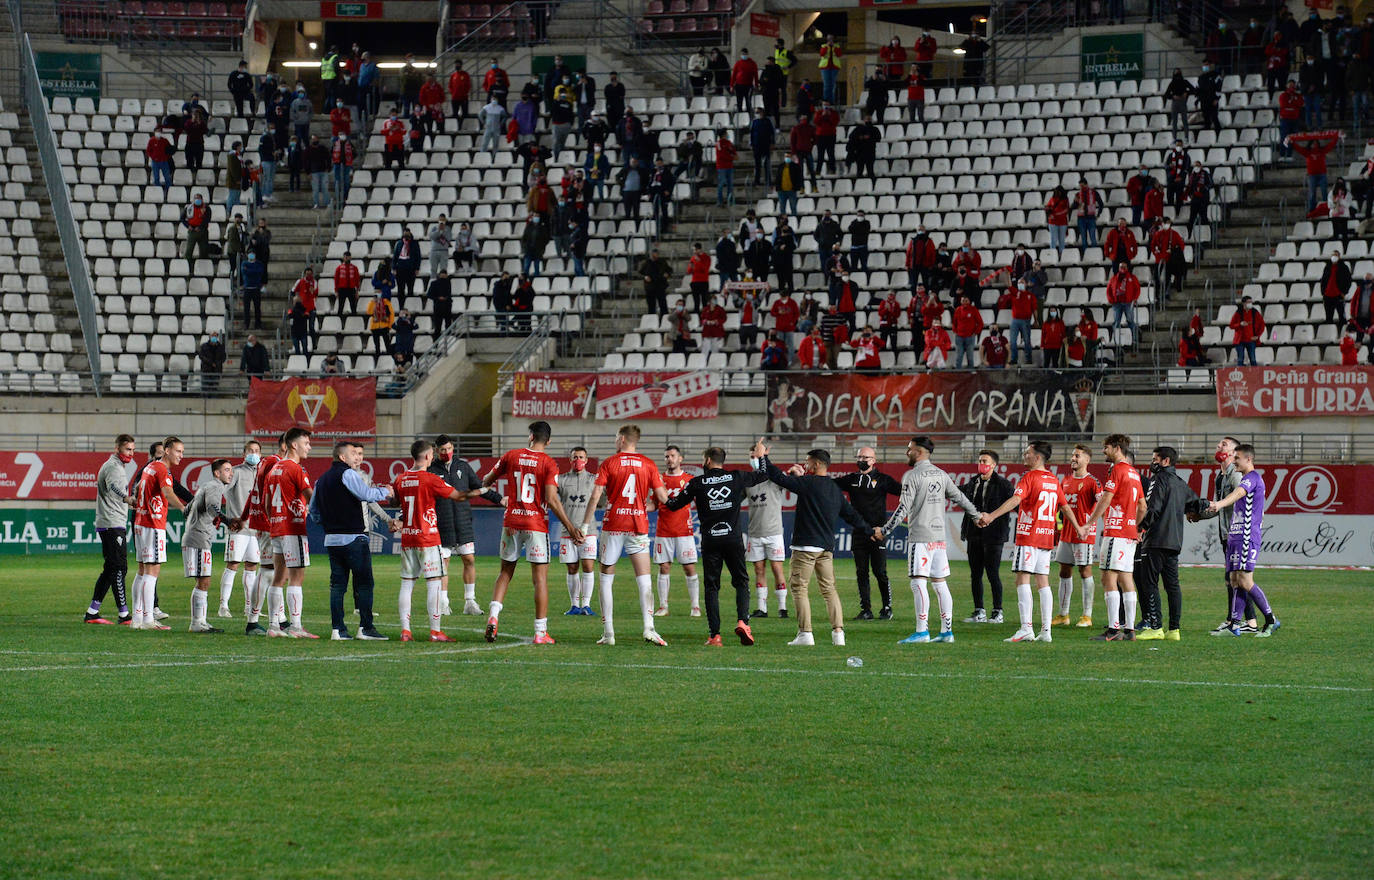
<box><xmin>1216</xmin><ymin>367</ymin><xmax>1374</xmax><ymax>418</ymax></box>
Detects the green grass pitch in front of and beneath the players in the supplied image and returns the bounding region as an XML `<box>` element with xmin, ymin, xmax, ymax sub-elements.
<box><xmin>0</xmin><ymin>556</ymin><xmax>1374</xmax><ymax>879</ymax></box>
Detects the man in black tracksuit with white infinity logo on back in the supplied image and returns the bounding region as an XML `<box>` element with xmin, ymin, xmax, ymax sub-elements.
<box><xmin>665</xmin><ymin>447</ymin><xmax>768</xmax><ymax>645</ymax></box>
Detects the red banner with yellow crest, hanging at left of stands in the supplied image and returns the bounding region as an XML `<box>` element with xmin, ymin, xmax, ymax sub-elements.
<box><xmin>243</xmin><ymin>377</ymin><xmax>376</xmax><ymax>437</ymax></box>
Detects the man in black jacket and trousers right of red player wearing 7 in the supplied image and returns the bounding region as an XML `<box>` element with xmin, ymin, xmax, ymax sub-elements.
<box><xmin>1135</xmin><ymin>446</ymin><xmax>1197</xmax><ymax>641</ymax></box>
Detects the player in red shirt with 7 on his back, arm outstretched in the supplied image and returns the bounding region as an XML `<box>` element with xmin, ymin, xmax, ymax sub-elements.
<box><xmin>392</xmin><ymin>440</ymin><xmax>478</xmax><ymax>642</ymax></box>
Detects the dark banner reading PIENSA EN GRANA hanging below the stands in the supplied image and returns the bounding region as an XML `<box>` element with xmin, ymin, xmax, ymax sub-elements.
<box><xmin>768</xmin><ymin>370</ymin><xmax>1101</xmax><ymax>435</ymax></box>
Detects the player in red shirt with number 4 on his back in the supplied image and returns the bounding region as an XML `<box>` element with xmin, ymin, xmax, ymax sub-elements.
<box><xmin>583</xmin><ymin>425</ymin><xmax>668</xmax><ymax>645</ymax></box>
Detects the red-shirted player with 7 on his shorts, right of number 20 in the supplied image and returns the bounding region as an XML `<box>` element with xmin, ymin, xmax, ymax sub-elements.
<box><xmin>1083</xmin><ymin>435</ymin><xmax>1145</xmax><ymax>642</ymax></box>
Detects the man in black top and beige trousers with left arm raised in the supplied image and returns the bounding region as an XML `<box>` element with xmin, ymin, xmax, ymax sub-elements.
<box><xmin>753</xmin><ymin>440</ymin><xmax>872</xmax><ymax>646</ymax></box>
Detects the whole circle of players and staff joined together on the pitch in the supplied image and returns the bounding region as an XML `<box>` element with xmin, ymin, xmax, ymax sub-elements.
<box><xmin>87</xmin><ymin>422</ymin><xmax>1279</xmax><ymax>646</ymax></box>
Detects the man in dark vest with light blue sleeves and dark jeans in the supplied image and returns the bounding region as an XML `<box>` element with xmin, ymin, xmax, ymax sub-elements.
<box><xmin>311</xmin><ymin>440</ymin><xmax>400</xmax><ymax>642</ymax></box>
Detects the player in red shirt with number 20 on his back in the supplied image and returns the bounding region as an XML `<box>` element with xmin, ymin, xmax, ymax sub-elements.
<box><xmin>978</xmin><ymin>440</ymin><xmax>1087</xmax><ymax>642</ymax></box>
